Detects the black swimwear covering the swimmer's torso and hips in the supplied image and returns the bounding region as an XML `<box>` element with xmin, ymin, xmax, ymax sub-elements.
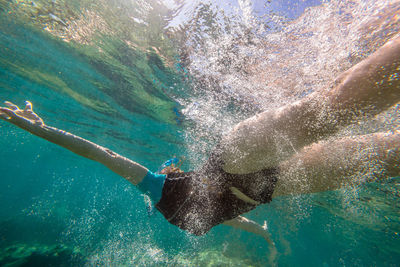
<box><xmin>156</xmin><ymin>155</ymin><xmax>278</xmax><ymax>235</ymax></box>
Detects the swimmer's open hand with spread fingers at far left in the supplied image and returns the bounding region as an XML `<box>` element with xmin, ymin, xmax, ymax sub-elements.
<box><xmin>0</xmin><ymin>101</ymin><xmax>45</xmax><ymax>128</ymax></box>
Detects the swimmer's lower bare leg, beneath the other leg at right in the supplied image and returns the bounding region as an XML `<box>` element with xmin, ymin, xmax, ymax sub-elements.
<box><xmin>273</xmin><ymin>131</ymin><xmax>400</xmax><ymax>197</ymax></box>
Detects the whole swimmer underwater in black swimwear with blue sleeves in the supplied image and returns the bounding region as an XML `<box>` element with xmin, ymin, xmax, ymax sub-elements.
<box><xmin>0</xmin><ymin>37</ymin><xmax>400</xmax><ymax>242</ymax></box>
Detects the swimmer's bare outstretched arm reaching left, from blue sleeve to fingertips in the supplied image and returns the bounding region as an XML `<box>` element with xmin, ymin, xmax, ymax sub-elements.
<box><xmin>0</xmin><ymin>101</ymin><xmax>148</xmax><ymax>185</ymax></box>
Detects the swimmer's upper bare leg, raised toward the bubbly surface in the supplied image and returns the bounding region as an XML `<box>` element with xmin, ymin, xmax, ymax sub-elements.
<box><xmin>222</xmin><ymin>37</ymin><xmax>400</xmax><ymax>173</ymax></box>
